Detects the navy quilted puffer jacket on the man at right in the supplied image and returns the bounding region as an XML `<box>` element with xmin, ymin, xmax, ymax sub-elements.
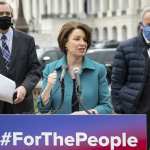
<box><xmin>111</xmin><ymin>35</ymin><xmax>148</xmax><ymax>114</ymax></box>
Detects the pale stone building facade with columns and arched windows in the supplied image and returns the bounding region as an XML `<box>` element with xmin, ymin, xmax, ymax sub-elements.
<box><xmin>7</xmin><ymin>0</ymin><xmax>150</xmax><ymax>45</ymax></box>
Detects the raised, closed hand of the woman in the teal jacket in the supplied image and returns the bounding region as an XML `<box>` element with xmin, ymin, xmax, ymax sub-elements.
<box><xmin>47</xmin><ymin>70</ymin><xmax>57</xmax><ymax>86</ymax></box>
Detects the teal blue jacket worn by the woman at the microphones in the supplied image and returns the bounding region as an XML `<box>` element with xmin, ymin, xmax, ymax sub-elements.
<box><xmin>38</xmin><ymin>57</ymin><xmax>112</xmax><ymax>114</ymax></box>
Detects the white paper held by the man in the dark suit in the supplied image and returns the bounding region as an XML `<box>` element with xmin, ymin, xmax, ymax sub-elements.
<box><xmin>0</xmin><ymin>74</ymin><xmax>16</xmax><ymax>104</ymax></box>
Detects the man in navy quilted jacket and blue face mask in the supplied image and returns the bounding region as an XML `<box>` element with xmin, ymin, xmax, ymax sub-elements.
<box><xmin>111</xmin><ymin>7</ymin><xmax>150</xmax><ymax>149</ymax></box>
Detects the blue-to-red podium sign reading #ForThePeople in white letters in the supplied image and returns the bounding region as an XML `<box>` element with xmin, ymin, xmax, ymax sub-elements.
<box><xmin>0</xmin><ymin>115</ymin><xmax>146</xmax><ymax>150</ymax></box>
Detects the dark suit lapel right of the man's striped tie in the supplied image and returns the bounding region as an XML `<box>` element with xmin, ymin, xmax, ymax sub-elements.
<box><xmin>10</xmin><ymin>29</ymin><xmax>19</xmax><ymax>69</ymax></box>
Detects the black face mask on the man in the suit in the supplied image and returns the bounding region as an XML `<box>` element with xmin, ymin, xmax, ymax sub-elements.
<box><xmin>0</xmin><ymin>16</ymin><xmax>12</xmax><ymax>30</ymax></box>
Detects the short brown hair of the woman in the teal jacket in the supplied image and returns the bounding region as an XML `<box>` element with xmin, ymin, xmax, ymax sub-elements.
<box><xmin>57</xmin><ymin>21</ymin><xmax>92</xmax><ymax>54</ymax></box>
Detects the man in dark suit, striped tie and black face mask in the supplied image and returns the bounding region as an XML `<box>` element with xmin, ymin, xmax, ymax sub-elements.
<box><xmin>0</xmin><ymin>1</ymin><xmax>41</xmax><ymax>114</ymax></box>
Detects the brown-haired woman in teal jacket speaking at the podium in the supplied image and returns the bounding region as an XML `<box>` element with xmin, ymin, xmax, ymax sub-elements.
<box><xmin>38</xmin><ymin>21</ymin><xmax>112</xmax><ymax>115</ymax></box>
